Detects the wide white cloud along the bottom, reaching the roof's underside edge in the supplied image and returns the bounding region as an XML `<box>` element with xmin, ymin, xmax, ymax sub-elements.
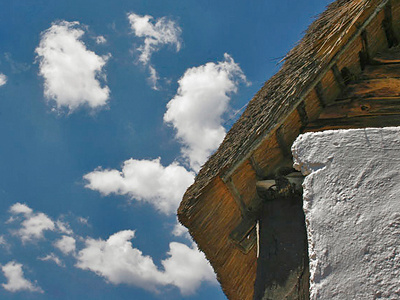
<box><xmin>76</xmin><ymin>230</ymin><xmax>215</xmax><ymax>294</ymax></box>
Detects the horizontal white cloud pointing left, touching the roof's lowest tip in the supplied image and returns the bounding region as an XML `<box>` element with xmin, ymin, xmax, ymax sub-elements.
<box><xmin>83</xmin><ymin>158</ymin><xmax>194</xmax><ymax>214</ymax></box>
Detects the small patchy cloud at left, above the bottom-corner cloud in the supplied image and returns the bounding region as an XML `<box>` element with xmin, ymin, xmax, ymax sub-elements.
<box><xmin>10</xmin><ymin>203</ymin><xmax>55</xmax><ymax>242</ymax></box>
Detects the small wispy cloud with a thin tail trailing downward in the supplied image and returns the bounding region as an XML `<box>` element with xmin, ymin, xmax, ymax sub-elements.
<box><xmin>128</xmin><ymin>13</ymin><xmax>182</xmax><ymax>90</ymax></box>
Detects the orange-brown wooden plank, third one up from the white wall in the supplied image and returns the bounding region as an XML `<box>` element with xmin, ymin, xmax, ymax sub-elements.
<box><xmin>339</xmin><ymin>78</ymin><xmax>400</xmax><ymax>100</ymax></box>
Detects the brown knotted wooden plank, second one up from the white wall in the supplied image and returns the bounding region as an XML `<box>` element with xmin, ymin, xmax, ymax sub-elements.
<box><xmin>319</xmin><ymin>98</ymin><xmax>400</xmax><ymax>119</ymax></box>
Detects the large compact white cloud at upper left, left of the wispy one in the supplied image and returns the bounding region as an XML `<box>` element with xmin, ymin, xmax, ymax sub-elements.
<box><xmin>36</xmin><ymin>21</ymin><xmax>110</xmax><ymax>111</ymax></box>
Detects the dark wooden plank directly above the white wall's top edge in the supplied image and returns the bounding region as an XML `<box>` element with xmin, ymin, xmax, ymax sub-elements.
<box><xmin>305</xmin><ymin>114</ymin><xmax>400</xmax><ymax>132</ymax></box>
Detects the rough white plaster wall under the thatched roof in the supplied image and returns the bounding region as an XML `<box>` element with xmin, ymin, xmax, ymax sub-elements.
<box><xmin>292</xmin><ymin>127</ymin><xmax>400</xmax><ymax>300</ymax></box>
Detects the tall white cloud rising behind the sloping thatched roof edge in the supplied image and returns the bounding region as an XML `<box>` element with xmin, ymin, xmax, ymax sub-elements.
<box><xmin>164</xmin><ymin>53</ymin><xmax>247</xmax><ymax>171</ymax></box>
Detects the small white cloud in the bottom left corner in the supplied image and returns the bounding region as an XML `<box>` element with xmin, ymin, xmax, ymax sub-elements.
<box><xmin>1</xmin><ymin>261</ymin><xmax>43</xmax><ymax>293</ymax></box>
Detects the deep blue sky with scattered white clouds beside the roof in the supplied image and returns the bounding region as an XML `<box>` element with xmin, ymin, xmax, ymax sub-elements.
<box><xmin>0</xmin><ymin>0</ymin><xmax>329</xmax><ymax>299</ymax></box>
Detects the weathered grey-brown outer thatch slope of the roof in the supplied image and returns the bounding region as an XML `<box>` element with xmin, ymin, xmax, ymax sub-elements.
<box><xmin>180</xmin><ymin>0</ymin><xmax>387</xmax><ymax>212</ymax></box>
